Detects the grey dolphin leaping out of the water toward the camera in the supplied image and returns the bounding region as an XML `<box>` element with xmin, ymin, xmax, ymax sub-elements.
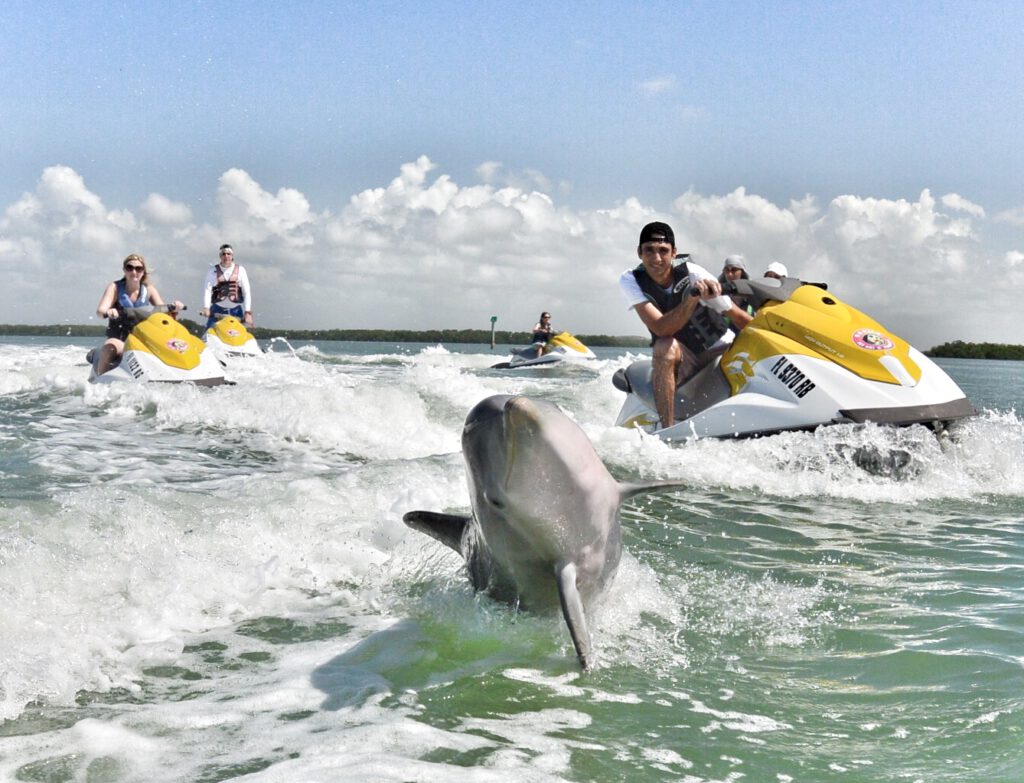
<box><xmin>402</xmin><ymin>394</ymin><xmax>683</xmax><ymax>669</ymax></box>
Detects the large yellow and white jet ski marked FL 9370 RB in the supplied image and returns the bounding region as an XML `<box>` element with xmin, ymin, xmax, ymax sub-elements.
<box><xmin>612</xmin><ymin>277</ymin><xmax>977</xmax><ymax>441</ymax></box>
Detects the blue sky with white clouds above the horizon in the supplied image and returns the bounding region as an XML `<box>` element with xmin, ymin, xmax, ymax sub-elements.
<box><xmin>0</xmin><ymin>0</ymin><xmax>1024</xmax><ymax>348</ymax></box>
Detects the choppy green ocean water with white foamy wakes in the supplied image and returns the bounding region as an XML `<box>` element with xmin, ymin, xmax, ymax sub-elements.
<box><xmin>0</xmin><ymin>338</ymin><xmax>1024</xmax><ymax>783</ymax></box>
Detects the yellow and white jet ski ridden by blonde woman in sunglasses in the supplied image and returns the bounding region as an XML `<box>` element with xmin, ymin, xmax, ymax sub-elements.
<box><xmin>86</xmin><ymin>305</ymin><xmax>224</xmax><ymax>386</ymax></box>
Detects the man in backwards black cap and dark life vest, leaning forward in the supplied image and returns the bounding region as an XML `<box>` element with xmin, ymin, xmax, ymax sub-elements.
<box><xmin>618</xmin><ymin>222</ymin><xmax>751</xmax><ymax>428</ymax></box>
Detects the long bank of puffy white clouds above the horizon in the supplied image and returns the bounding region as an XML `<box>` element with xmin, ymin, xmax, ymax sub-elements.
<box><xmin>0</xmin><ymin>156</ymin><xmax>1024</xmax><ymax>347</ymax></box>
